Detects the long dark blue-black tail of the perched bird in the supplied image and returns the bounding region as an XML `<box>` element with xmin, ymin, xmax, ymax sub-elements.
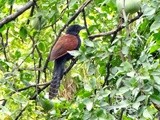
<box><xmin>49</xmin><ymin>58</ymin><xmax>66</xmax><ymax>99</ymax></box>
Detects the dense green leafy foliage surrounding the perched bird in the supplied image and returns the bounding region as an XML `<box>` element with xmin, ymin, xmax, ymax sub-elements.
<box><xmin>0</xmin><ymin>0</ymin><xmax>160</xmax><ymax>120</ymax></box>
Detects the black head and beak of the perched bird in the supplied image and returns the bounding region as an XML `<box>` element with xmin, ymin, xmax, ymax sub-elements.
<box><xmin>66</xmin><ymin>24</ymin><xmax>85</xmax><ymax>35</ymax></box>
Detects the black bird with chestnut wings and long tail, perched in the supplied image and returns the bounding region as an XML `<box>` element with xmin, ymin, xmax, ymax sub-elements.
<box><xmin>49</xmin><ymin>24</ymin><xmax>85</xmax><ymax>99</ymax></box>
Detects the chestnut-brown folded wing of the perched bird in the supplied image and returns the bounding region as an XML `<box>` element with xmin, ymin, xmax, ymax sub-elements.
<box><xmin>50</xmin><ymin>34</ymin><xmax>78</xmax><ymax>60</ymax></box>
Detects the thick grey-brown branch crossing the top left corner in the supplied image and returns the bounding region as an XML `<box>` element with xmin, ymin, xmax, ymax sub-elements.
<box><xmin>0</xmin><ymin>1</ymin><xmax>35</xmax><ymax>28</ymax></box>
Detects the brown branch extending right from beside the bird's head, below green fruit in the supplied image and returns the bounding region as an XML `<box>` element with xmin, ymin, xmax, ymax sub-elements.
<box><xmin>89</xmin><ymin>13</ymin><xmax>143</xmax><ymax>39</ymax></box>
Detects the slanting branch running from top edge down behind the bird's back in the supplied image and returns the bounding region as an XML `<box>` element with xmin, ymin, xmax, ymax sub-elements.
<box><xmin>43</xmin><ymin>0</ymin><xmax>92</xmax><ymax>72</ymax></box>
